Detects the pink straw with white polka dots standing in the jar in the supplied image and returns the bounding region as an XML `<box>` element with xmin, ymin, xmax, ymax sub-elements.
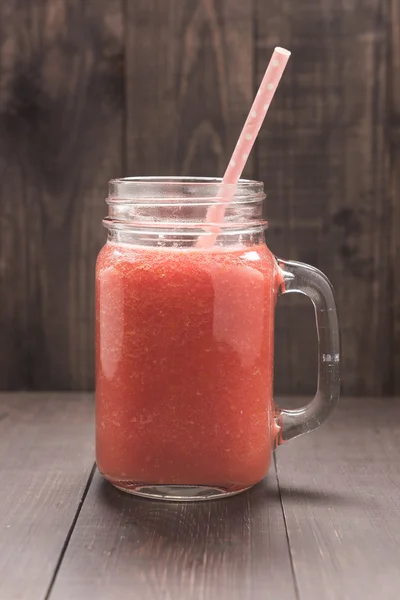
<box><xmin>197</xmin><ymin>48</ymin><xmax>290</xmax><ymax>247</ymax></box>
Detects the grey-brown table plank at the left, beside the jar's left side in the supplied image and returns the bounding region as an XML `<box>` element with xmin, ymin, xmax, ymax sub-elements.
<box><xmin>0</xmin><ymin>394</ymin><xmax>94</xmax><ymax>600</ymax></box>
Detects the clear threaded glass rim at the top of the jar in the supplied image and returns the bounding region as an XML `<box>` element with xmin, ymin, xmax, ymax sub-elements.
<box><xmin>103</xmin><ymin>176</ymin><xmax>266</xmax><ymax>229</ymax></box>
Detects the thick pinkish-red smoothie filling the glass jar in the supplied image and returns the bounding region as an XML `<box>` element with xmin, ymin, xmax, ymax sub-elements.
<box><xmin>96</xmin><ymin>243</ymin><xmax>278</xmax><ymax>489</ymax></box>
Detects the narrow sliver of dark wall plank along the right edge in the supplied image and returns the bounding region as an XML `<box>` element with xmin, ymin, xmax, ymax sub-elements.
<box><xmin>389</xmin><ymin>0</ymin><xmax>400</xmax><ymax>393</ymax></box>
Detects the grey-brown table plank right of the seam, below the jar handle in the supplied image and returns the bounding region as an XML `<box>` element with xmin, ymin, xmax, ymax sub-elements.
<box><xmin>276</xmin><ymin>398</ymin><xmax>400</xmax><ymax>600</ymax></box>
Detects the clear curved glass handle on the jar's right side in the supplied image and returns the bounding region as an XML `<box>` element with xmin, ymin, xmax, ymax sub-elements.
<box><xmin>276</xmin><ymin>259</ymin><xmax>340</xmax><ymax>446</ymax></box>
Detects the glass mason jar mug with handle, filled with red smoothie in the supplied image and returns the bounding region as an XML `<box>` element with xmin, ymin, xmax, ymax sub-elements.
<box><xmin>96</xmin><ymin>177</ymin><xmax>340</xmax><ymax>500</ymax></box>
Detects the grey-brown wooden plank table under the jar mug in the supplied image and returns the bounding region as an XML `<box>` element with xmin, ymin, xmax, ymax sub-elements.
<box><xmin>0</xmin><ymin>394</ymin><xmax>400</xmax><ymax>600</ymax></box>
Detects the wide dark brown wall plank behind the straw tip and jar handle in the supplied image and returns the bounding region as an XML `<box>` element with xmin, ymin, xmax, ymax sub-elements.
<box><xmin>255</xmin><ymin>0</ymin><xmax>394</xmax><ymax>394</ymax></box>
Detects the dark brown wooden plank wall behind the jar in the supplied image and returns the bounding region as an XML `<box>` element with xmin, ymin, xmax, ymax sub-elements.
<box><xmin>0</xmin><ymin>0</ymin><xmax>400</xmax><ymax>395</ymax></box>
